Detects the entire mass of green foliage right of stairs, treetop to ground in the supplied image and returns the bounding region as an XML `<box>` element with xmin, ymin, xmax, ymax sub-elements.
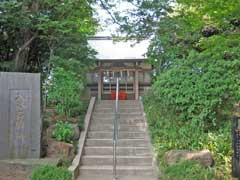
<box><xmin>111</xmin><ymin>0</ymin><xmax>240</xmax><ymax>179</ymax></box>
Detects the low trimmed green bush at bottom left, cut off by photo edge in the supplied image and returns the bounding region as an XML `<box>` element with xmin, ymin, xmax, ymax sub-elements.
<box><xmin>30</xmin><ymin>165</ymin><xmax>72</xmax><ymax>180</ymax></box>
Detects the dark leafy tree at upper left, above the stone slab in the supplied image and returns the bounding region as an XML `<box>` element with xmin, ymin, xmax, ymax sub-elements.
<box><xmin>0</xmin><ymin>0</ymin><xmax>97</xmax><ymax>72</ymax></box>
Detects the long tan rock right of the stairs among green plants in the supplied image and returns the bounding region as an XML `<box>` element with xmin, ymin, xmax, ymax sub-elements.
<box><xmin>165</xmin><ymin>150</ymin><xmax>214</xmax><ymax>167</ymax></box>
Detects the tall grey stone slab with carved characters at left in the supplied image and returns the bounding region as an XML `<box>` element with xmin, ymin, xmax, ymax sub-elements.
<box><xmin>0</xmin><ymin>72</ymin><xmax>42</xmax><ymax>159</ymax></box>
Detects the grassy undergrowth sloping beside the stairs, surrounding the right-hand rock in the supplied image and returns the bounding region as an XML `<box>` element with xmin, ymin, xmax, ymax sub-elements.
<box><xmin>144</xmin><ymin>93</ymin><xmax>232</xmax><ymax>180</ymax></box>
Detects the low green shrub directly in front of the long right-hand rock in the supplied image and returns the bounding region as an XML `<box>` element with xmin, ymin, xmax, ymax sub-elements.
<box><xmin>164</xmin><ymin>161</ymin><xmax>216</xmax><ymax>180</ymax></box>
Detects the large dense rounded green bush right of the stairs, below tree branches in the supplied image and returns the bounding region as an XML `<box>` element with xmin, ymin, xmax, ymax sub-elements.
<box><xmin>153</xmin><ymin>34</ymin><xmax>240</xmax><ymax>130</ymax></box>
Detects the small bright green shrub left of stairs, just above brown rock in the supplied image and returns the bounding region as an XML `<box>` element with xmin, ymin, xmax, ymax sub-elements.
<box><xmin>52</xmin><ymin>121</ymin><xmax>74</xmax><ymax>142</ymax></box>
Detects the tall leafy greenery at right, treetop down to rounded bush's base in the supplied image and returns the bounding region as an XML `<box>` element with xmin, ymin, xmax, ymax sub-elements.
<box><xmin>112</xmin><ymin>0</ymin><xmax>240</xmax><ymax>126</ymax></box>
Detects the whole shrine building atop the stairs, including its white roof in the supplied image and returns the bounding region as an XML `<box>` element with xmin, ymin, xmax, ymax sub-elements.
<box><xmin>87</xmin><ymin>37</ymin><xmax>152</xmax><ymax>100</ymax></box>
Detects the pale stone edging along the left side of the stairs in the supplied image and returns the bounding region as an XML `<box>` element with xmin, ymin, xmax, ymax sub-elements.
<box><xmin>68</xmin><ymin>97</ymin><xmax>96</xmax><ymax>180</ymax></box>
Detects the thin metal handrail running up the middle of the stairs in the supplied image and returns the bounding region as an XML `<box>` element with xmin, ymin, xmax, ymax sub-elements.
<box><xmin>113</xmin><ymin>78</ymin><xmax>119</xmax><ymax>180</ymax></box>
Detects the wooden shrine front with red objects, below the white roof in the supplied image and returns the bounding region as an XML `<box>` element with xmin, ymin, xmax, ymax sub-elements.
<box><xmin>87</xmin><ymin>60</ymin><xmax>151</xmax><ymax>100</ymax></box>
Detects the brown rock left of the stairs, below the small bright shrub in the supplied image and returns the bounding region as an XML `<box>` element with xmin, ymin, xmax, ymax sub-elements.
<box><xmin>47</xmin><ymin>141</ymin><xmax>74</xmax><ymax>159</ymax></box>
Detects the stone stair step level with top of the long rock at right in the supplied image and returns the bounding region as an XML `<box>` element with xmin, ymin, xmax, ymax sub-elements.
<box><xmin>84</xmin><ymin>146</ymin><xmax>151</xmax><ymax>156</ymax></box>
